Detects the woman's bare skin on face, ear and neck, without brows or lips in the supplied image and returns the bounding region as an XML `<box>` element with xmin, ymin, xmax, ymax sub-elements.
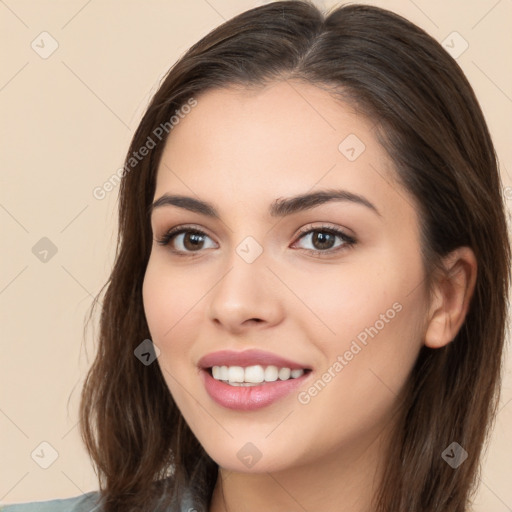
<box><xmin>143</xmin><ymin>81</ymin><xmax>476</xmax><ymax>512</ymax></box>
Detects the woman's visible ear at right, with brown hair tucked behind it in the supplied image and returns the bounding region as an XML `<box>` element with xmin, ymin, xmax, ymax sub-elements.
<box><xmin>425</xmin><ymin>247</ymin><xmax>478</xmax><ymax>348</ymax></box>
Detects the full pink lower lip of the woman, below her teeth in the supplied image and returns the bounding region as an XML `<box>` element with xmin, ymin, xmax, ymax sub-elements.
<box><xmin>201</xmin><ymin>369</ymin><xmax>312</xmax><ymax>411</ymax></box>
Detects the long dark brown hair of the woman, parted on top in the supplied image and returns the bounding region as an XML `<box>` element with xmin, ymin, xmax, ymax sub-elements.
<box><xmin>80</xmin><ymin>0</ymin><xmax>510</xmax><ymax>512</ymax></box>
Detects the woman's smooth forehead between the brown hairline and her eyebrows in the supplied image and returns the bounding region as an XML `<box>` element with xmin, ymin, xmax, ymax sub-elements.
<box><xmin>155</xmin><ymin>81</ymin><xmax>404</xmax><ymax>218</ymax></box>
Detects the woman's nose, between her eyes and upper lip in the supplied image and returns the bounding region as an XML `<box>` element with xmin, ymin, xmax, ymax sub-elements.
<box><xmin>207</xmin><ymin>254</ymin><xmax>284</xmax><ymax>334</ymax></box>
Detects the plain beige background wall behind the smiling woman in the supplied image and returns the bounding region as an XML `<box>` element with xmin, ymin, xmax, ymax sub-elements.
<box><xmin>0</xmin><ymin>0</ymin><xmax>512</xmax><ymax>512</ymax></box>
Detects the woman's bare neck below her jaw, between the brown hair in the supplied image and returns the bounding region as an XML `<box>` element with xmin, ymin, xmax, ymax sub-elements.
<box><xmin>209</xmin><ymin>418</ymin><xmax>390</xmax><ymax>512</ymax></box>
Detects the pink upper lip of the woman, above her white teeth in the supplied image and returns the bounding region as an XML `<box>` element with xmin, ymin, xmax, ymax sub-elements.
<box><xmin>198</xmin><ymin>349</ymin><xmax>311</xmax><ymax>370</ymax></box>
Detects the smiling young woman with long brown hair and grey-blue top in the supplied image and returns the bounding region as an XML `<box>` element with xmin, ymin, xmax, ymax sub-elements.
<box><xmin>6</xmin><ymin>1</ymin><xmax>510</xmax><ymax>512</ymax></box>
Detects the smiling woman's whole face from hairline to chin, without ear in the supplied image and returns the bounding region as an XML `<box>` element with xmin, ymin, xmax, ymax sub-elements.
<box><xmin>143</xmin><ymin>82</ymin><xmax>427</xmax><ymax>472</ymax></box>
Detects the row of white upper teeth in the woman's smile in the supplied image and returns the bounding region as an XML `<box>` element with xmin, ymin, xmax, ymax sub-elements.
<box><xmin>212</xmin><ymin>364</ymin><xmax>304</xmax><ymax>386</ymax></box>
